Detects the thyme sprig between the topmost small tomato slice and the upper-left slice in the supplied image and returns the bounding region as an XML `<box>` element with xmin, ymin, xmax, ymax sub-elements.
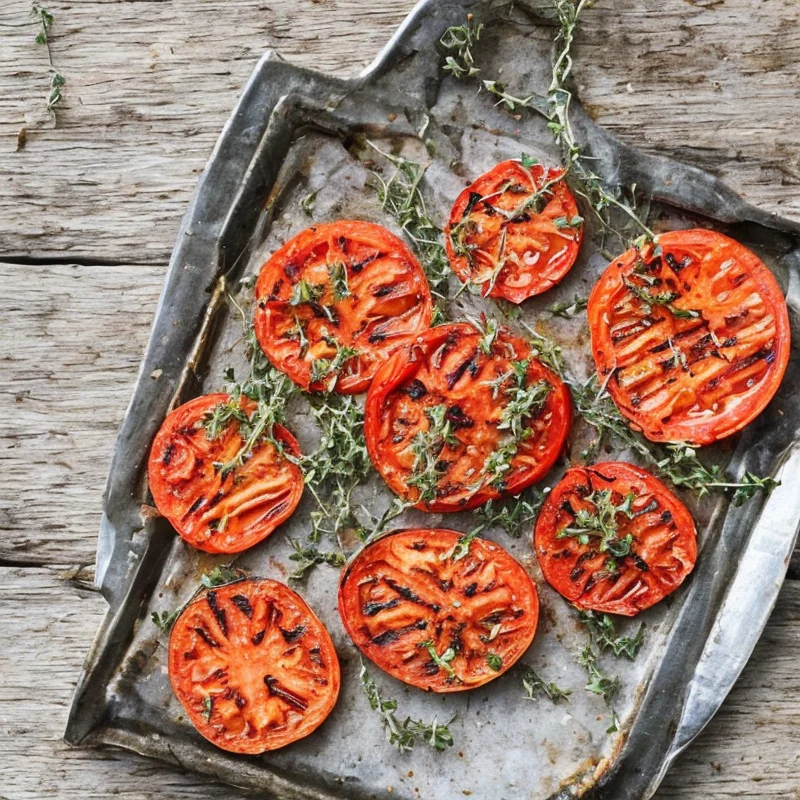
<box><xmin>370</xmin><ymin>143</ymin><xmax>450</xmax><ymax>325</ymax></box>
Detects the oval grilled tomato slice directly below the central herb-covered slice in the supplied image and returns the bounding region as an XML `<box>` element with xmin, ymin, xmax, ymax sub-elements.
<box><xmin>339</xmin><ymin>529</ymin><xmax>539</xmax><ymax>692</ymax></box>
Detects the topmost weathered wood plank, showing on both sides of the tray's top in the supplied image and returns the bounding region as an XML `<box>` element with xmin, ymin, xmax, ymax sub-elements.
<box><xmin>0</xmin><ymin>0</ymin><xmax>800</xmax><ymax>264</ymax></box>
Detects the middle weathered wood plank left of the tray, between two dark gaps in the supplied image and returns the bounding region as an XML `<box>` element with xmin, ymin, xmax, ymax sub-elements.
<box><xmin>0</xmin><ymin>264</ymin><xmax>165</xmax><ymax>564</ymax></box>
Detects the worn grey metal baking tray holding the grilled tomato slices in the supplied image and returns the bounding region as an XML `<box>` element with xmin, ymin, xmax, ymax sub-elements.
<box><xmin>66</xmin><ymin>0</ymin><xmax>800</xmax><ymax>800</ymax></box>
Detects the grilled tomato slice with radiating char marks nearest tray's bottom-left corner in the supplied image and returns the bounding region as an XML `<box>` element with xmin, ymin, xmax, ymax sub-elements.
<box><xmin>169</xmin><ymin>580</ymin><xmax>341</xmax><ymax>755</ymax></box>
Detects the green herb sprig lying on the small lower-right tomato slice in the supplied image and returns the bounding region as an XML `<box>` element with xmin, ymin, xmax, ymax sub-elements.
<box><xmin>556</xmin><ymin>489</ymin><xmax>634</xmax><ymax>574</ymax></box>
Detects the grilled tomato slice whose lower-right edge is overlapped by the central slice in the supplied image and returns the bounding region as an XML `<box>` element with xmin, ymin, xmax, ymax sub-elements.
<box><xmin>255</xmin><ymin>220</ymin><xmax>433</xmax><ymax>394</ymax></box>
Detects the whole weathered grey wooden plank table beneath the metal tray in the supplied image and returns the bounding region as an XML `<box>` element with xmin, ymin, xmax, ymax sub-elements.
<box><xmin>0</xmin><ymin>0</ymin><xmax>800</xmax><ymax>800</ymax></box>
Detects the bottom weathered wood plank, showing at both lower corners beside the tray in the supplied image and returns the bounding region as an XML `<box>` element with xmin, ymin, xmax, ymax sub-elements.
<box><xmin>0</xmin><ymin>568</ymin><xmax>800</xmax><ymax>800</ymax></box>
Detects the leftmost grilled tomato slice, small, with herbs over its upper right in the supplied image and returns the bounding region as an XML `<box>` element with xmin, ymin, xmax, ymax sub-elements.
<box><xmin>147</xmin><ymin>394</ymin><xmax>303</xmax><ymax>553</ymax></box>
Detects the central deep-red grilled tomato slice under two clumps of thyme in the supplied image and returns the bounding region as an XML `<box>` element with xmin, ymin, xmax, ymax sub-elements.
<box><xmin>364</xmin><ymin>323</ymin><xmax>572</xmax><ymax>512</ymax></box>
